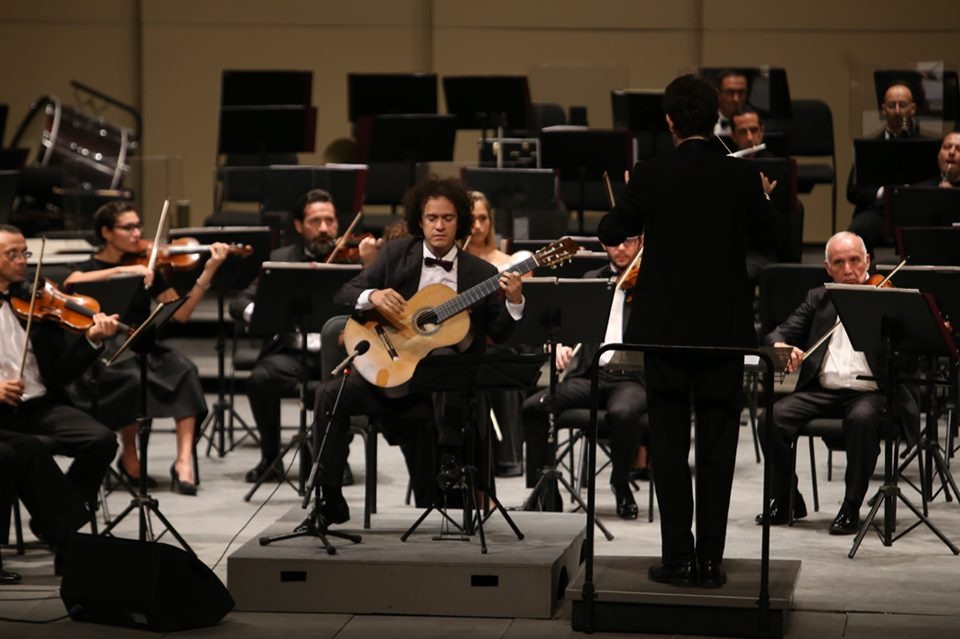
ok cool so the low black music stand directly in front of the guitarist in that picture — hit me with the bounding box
[400,352,545,554]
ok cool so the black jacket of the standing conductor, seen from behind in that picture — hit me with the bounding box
[597,140,773,346]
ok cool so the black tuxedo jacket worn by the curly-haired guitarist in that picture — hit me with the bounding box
[333,237,516,352]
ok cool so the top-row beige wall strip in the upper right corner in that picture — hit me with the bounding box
[703,0,960,33]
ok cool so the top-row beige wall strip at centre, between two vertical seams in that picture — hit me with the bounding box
[433,0,701,31]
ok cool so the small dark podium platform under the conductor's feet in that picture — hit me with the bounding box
[566,556,800,637]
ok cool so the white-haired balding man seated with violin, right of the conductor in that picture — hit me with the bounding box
[757,231,920,535]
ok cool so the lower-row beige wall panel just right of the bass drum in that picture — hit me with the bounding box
[143,25,428,223]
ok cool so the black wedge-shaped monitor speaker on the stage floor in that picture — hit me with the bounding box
[60,534,234,632]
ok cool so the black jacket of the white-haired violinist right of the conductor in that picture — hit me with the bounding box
[764,286,920,435]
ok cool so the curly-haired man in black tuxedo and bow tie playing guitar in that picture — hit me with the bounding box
[314,176,523,525]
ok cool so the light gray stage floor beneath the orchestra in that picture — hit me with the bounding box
[0,388,960,639]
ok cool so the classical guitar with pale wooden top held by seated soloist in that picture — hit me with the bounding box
[343,238,579,388]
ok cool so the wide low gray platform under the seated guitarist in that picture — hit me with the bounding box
[227,508,586,619]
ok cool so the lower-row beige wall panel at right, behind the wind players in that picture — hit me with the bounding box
[703,30,958,242]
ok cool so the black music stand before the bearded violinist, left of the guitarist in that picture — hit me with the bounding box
[243,262,361,501]
